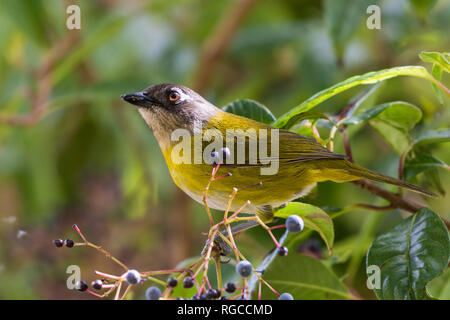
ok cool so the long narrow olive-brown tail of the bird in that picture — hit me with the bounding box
[345,160,437,198]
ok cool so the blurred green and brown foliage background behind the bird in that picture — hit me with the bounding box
[0,0,450,299]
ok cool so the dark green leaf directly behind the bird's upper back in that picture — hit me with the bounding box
[222,99,275,124]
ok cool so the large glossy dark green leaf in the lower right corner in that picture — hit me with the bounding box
[367,208,450,299]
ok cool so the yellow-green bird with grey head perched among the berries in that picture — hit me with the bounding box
[122,84,434,222]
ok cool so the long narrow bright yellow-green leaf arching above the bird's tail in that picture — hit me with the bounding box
[273,66,434,128]
